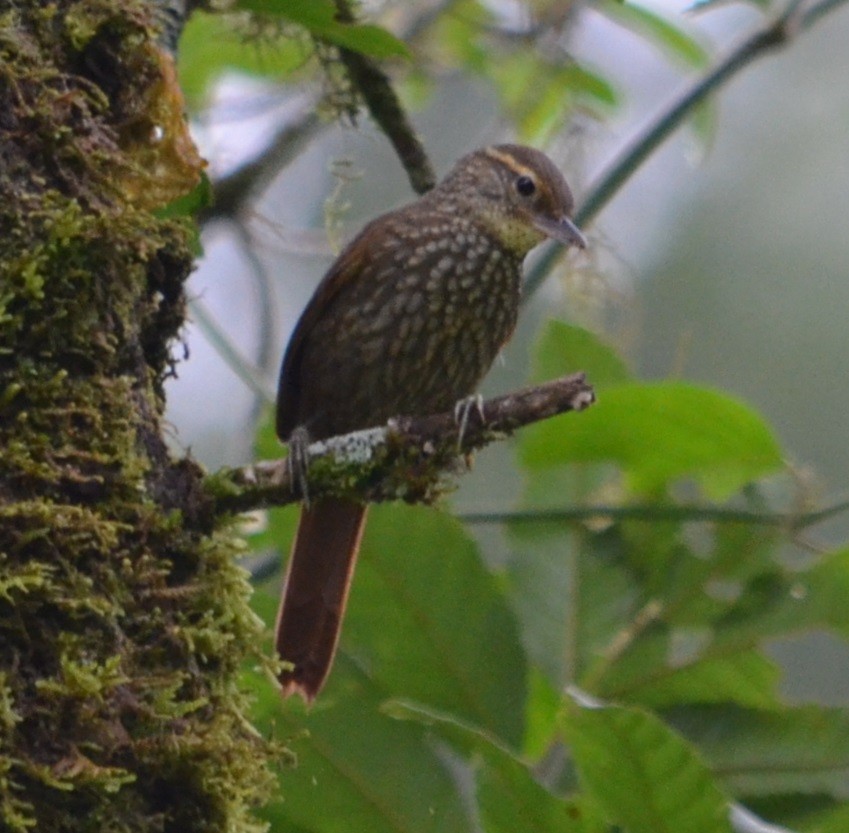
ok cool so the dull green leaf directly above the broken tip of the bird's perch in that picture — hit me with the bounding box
[531,319,631,392]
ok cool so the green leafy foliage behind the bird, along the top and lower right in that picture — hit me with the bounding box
[176,0,849,833]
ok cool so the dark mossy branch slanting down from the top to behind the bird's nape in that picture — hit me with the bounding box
[336,0,436,194]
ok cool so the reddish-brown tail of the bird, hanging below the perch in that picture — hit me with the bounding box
[275,498,366,703]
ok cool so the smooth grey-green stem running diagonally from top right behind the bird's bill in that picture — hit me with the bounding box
[523,0,846,302]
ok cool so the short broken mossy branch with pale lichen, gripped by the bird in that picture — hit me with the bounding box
[207,373,595,514]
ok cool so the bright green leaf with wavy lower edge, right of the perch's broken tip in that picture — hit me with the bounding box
[522,382,781,498]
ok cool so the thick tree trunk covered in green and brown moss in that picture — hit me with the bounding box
[0,0,269,833]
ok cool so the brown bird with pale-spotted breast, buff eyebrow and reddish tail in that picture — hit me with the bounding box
[275,144,586,703]
